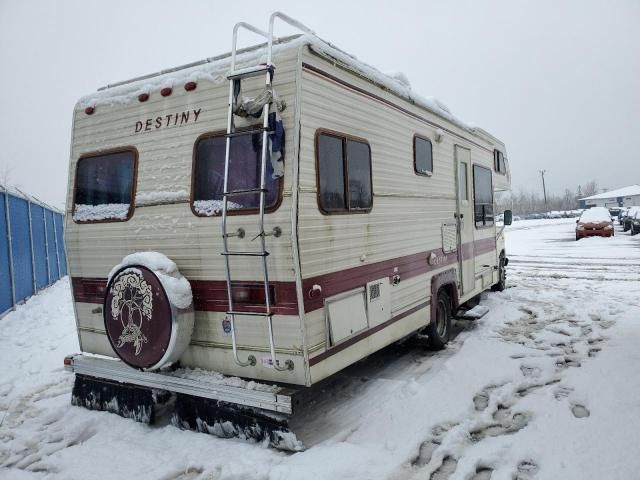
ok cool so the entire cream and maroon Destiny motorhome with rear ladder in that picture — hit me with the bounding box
[65,13,510,446]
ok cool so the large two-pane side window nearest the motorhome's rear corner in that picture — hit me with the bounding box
[316,131,373,213]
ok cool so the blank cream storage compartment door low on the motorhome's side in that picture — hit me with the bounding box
[326,288,367,345]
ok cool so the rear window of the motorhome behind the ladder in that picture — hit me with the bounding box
[191,133,282,217]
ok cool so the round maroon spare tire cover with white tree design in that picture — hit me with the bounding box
[103,265,186,370]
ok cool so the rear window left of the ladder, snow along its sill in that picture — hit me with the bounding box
[73,149,137,223]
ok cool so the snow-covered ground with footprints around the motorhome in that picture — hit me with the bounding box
[0,219,640,480]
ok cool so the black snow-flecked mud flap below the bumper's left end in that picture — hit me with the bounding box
[71,374,155,424]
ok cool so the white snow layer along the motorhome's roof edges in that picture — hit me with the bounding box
[78,33,502,143]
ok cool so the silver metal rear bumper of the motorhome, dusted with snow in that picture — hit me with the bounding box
[64,354,297,415]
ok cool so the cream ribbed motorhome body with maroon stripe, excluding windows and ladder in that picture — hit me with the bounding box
[65,31,509,386]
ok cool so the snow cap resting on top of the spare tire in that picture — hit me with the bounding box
[107,252,193,309]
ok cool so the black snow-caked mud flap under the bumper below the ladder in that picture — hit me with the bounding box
[171,394,304,451]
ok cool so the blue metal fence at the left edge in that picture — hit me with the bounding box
[0,185,67,316]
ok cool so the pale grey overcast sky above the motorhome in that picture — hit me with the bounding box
[0,0,640,207]
